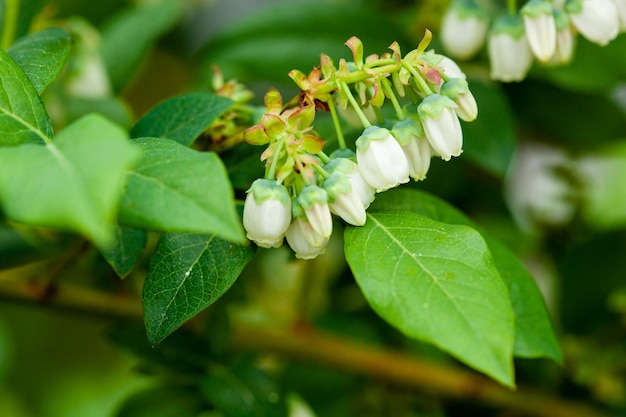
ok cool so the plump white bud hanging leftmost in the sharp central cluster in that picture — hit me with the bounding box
[243,179,291,248]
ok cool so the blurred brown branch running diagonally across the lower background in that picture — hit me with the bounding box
[0,277,609,417]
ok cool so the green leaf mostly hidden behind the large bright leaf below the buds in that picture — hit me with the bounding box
[371,188,562,363]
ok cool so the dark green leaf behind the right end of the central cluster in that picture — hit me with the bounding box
[463,80,516,178]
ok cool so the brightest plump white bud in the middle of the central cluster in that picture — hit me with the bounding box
[356,126,409,192]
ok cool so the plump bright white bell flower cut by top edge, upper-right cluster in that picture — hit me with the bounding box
[565,0,620,46]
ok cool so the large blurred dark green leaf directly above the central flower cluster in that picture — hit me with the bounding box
[197,2,414,86]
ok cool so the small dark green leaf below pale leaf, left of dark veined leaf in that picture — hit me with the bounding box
[100,225,148,278]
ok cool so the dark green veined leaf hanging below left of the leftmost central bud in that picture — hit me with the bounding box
[143,233,253,344]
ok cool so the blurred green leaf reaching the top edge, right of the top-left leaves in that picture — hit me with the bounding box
[102,1,184,91]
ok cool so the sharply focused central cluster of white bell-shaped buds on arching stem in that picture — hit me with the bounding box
[243,31,478,259]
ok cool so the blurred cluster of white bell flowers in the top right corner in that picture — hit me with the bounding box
[441,0,626,82]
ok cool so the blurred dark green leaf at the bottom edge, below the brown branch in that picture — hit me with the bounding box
[200,364,287,417]
